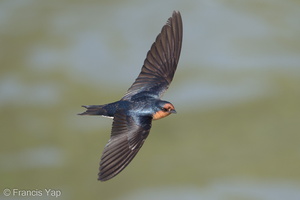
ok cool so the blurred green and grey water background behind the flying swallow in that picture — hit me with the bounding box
[0,0,300,200]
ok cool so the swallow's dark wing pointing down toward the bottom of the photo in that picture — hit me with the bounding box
[98,110,152,181]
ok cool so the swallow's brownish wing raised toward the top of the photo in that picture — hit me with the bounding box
[122,11,182,100]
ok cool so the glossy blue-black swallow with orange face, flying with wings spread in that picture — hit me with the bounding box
[79,11,183,181]
